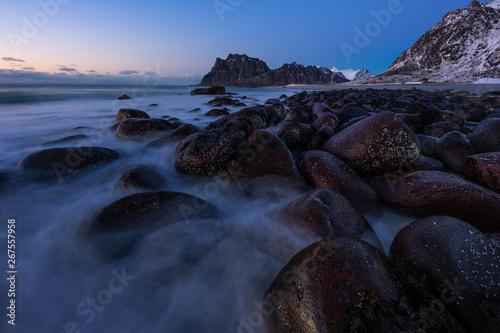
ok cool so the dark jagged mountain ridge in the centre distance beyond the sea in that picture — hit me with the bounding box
[199,54,347,87]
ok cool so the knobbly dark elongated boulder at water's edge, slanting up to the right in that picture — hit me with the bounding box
[175,107,267,176]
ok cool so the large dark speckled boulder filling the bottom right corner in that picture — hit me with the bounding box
[390,216,500,332]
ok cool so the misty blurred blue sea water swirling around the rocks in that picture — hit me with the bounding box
[0,85,411,333]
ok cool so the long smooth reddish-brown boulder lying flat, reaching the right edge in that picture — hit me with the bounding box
[370,171,500,231]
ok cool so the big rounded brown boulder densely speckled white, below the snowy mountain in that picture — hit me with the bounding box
[322,112,420,177]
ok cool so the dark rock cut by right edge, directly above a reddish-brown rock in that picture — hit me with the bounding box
[467,118,500,153]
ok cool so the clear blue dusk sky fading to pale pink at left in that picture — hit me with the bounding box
[0,0,487,84]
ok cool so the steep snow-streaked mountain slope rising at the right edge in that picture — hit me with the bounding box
[377,0,500,82]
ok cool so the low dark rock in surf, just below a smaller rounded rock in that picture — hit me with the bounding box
[116,119,176,141]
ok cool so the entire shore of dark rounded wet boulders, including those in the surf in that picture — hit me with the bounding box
[11,84,500,333]
